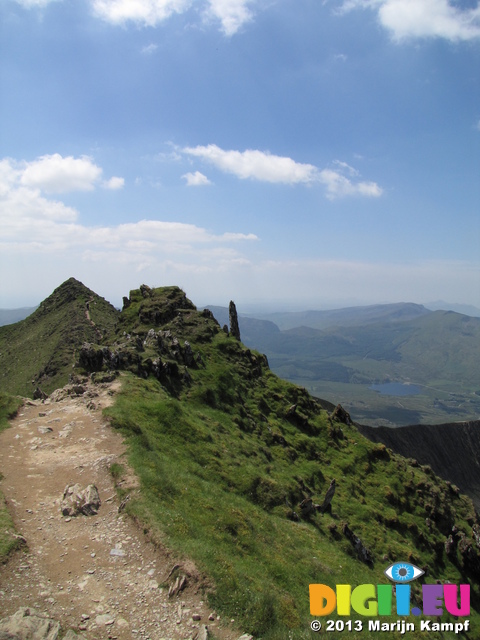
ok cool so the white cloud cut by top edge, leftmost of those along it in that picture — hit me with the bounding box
[92,0,192,27]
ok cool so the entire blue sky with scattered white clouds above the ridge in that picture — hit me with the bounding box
[0,0,480,310]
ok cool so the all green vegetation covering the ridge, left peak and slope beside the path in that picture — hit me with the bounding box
[0,280,480,640]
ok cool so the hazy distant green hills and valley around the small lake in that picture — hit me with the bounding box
[210,305,480,426]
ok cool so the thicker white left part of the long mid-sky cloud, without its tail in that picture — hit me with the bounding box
[183,144,317,184]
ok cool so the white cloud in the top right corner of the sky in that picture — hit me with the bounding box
[341,0,480,42]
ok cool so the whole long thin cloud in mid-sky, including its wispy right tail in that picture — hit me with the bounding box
[182,144,382,200]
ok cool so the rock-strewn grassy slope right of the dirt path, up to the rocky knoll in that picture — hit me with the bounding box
[98,288,480,639]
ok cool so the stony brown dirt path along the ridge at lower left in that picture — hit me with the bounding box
[0,382,240,640]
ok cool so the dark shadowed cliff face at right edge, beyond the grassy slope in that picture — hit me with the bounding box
[358,420,480,511]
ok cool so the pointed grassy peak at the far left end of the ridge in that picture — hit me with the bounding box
[0,278,118,397]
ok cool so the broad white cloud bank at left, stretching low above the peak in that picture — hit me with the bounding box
[0,158,258,262]
